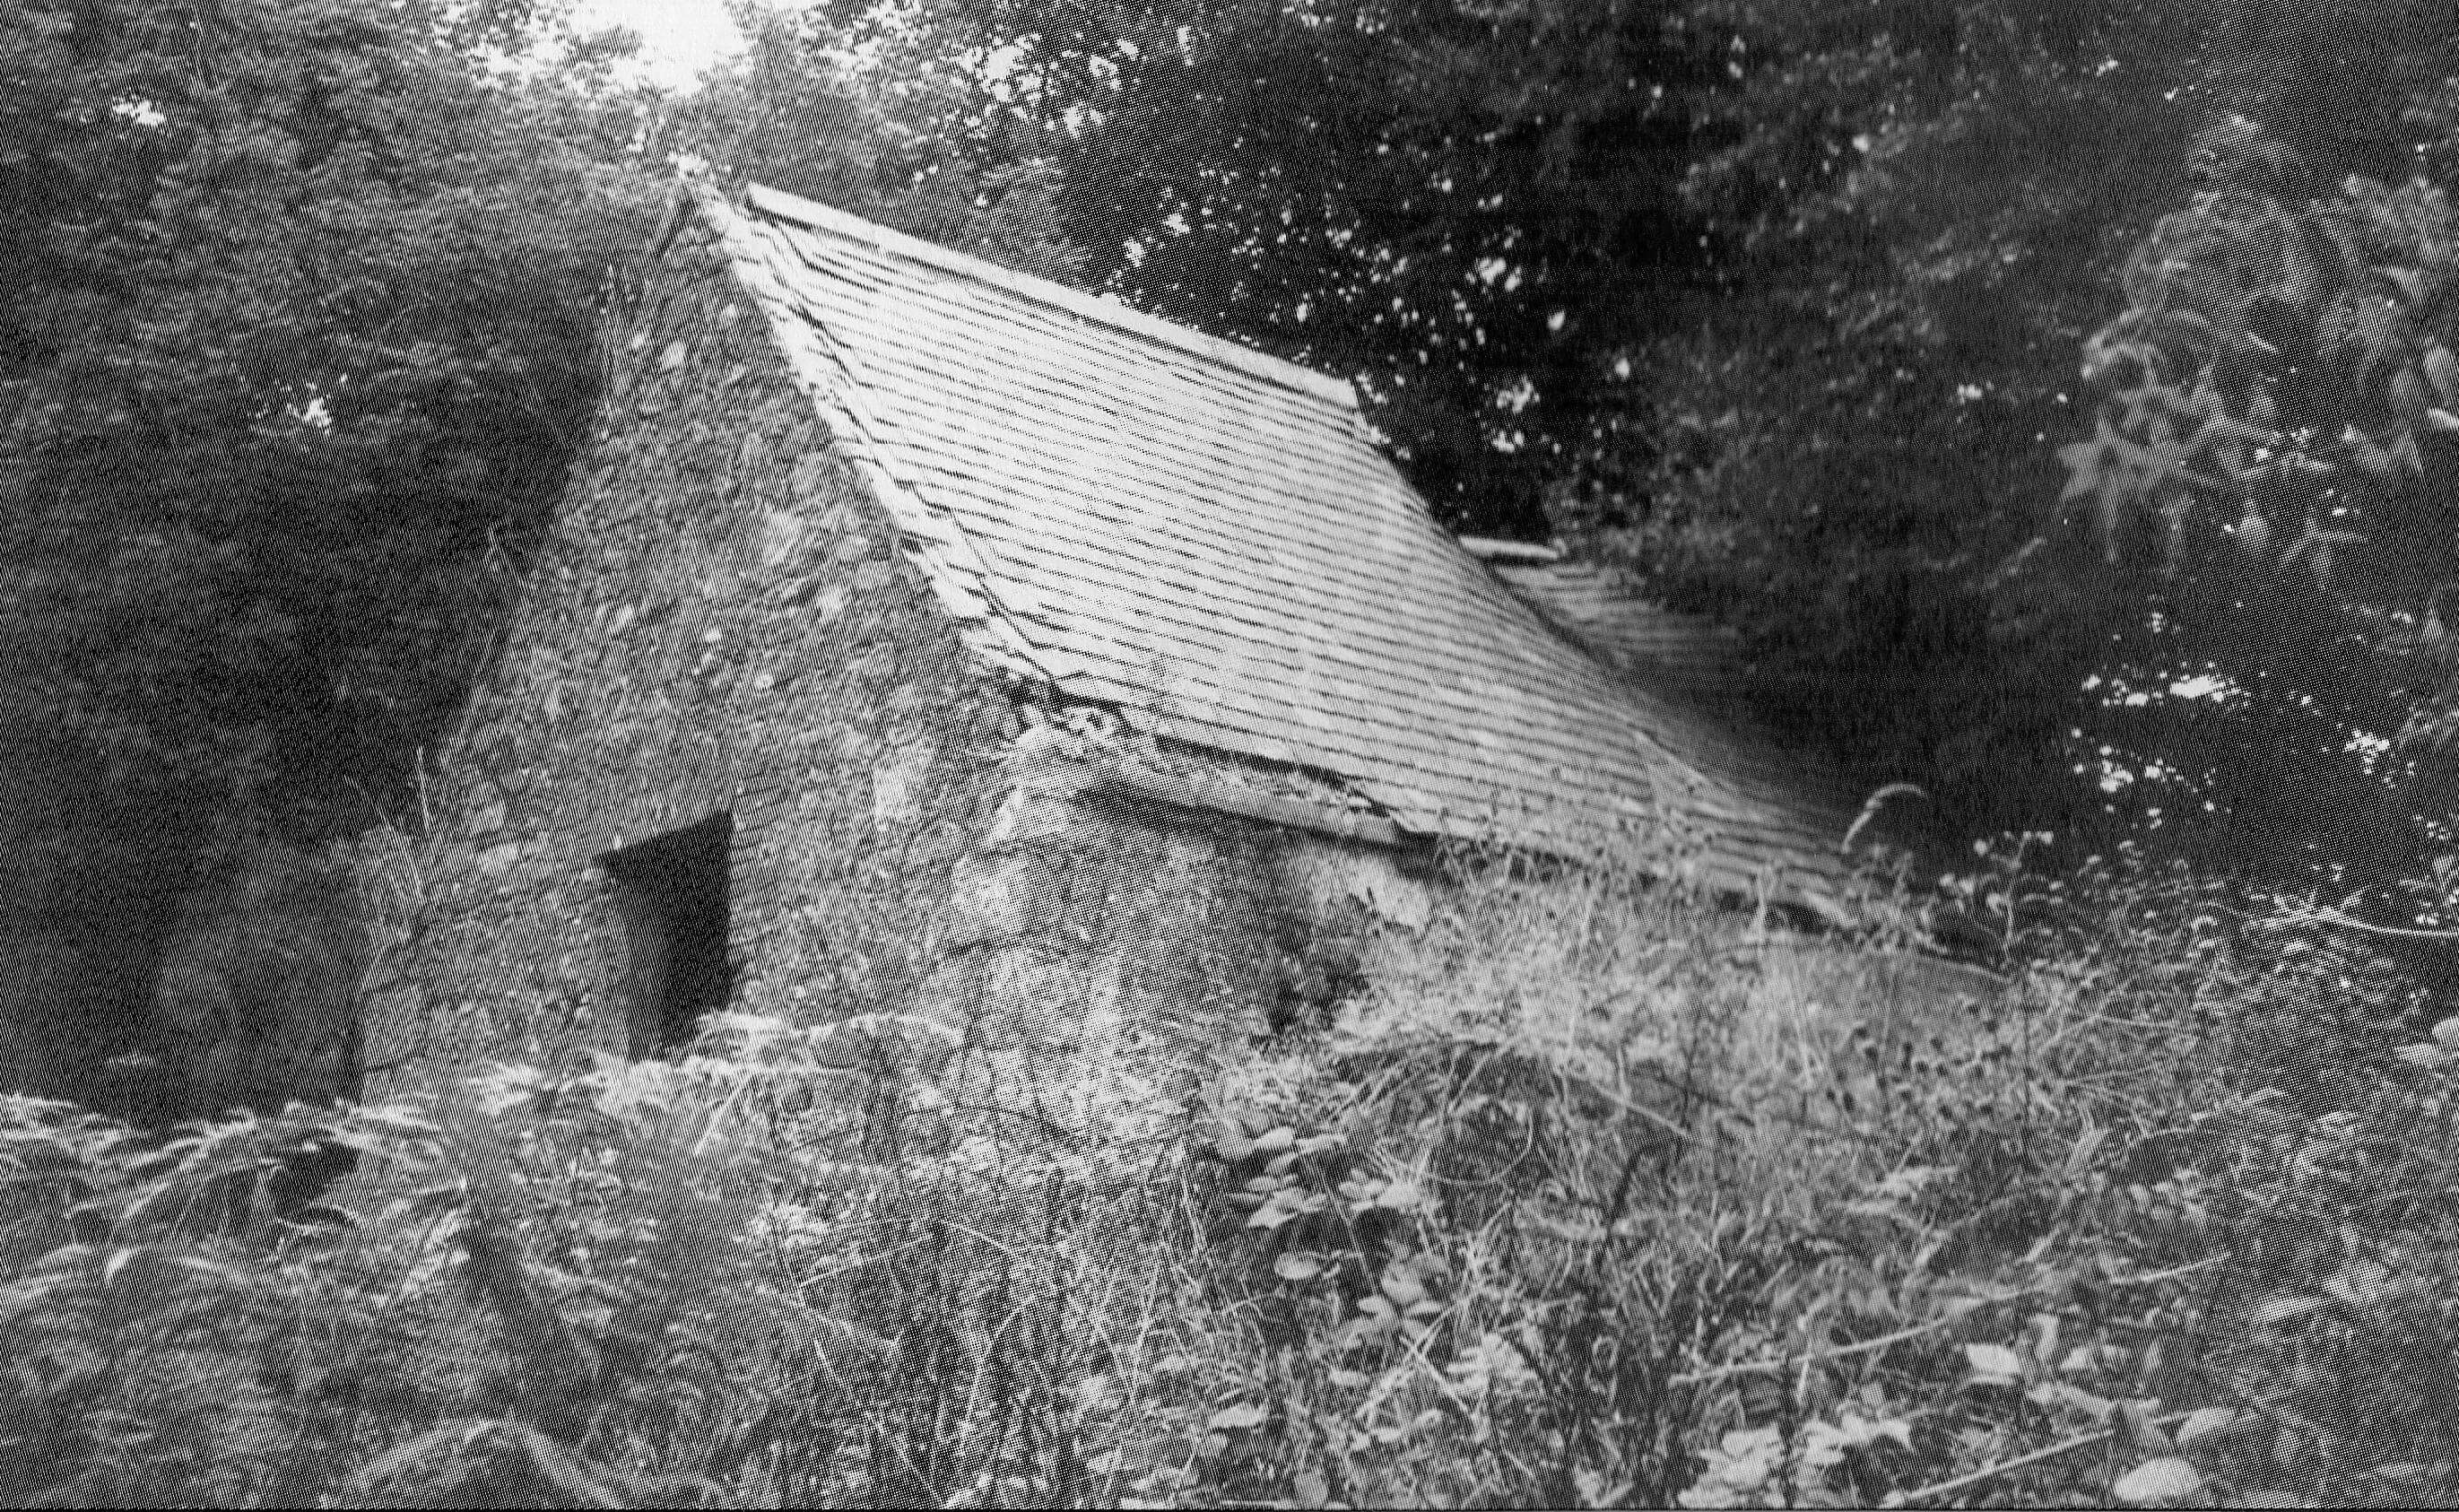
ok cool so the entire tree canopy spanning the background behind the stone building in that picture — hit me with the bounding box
[14,0,2459,899]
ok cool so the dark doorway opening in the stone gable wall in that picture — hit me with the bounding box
[597,813,735,1060]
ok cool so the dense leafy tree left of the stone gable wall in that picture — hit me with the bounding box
[0,0,654,870]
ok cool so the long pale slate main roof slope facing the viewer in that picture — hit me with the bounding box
[693,185,1846,898]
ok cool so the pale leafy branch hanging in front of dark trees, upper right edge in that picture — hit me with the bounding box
[2058,118,2459,593]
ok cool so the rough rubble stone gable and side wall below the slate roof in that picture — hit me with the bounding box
[361,210,1404,1111]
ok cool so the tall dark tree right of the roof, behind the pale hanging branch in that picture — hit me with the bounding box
[1623,0,2446,868]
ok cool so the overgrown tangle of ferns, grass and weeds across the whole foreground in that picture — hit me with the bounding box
[0,848,2459,1508]
